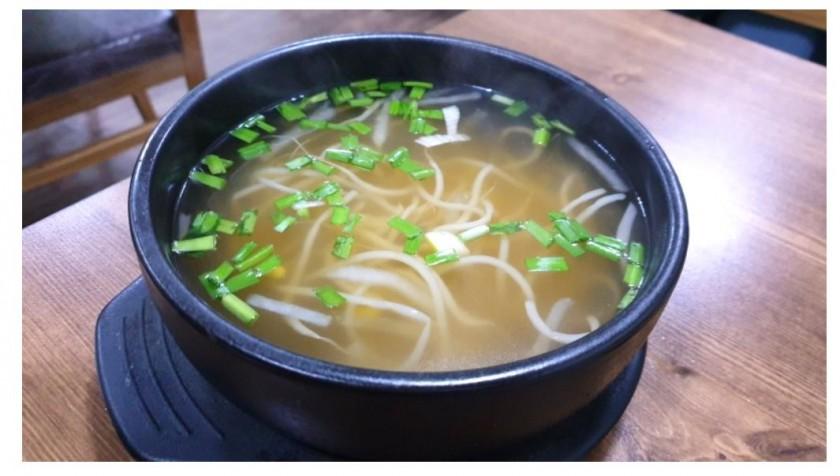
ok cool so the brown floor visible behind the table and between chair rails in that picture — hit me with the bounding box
[22,10,460,226]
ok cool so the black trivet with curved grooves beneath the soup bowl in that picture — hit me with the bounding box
[96,279,645,461]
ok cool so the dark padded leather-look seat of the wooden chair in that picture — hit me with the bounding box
[23,10,181,104]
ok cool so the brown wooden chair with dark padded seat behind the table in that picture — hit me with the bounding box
[23,10,206,192]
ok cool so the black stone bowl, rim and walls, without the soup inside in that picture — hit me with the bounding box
[129,34,688,458]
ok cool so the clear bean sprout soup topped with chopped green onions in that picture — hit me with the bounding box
[172,80,646,371]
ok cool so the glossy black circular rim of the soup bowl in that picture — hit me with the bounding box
[128,33,688,392]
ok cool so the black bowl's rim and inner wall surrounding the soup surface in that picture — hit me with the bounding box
[129,34,688,384]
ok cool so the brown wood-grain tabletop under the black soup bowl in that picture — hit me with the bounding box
[23,11,826,460]
